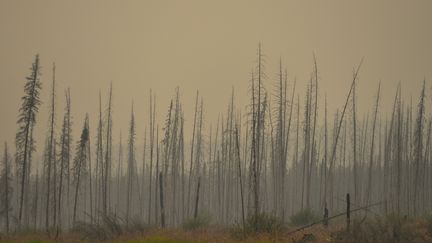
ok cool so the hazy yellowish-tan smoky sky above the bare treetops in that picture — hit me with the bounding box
[0,0,432,148]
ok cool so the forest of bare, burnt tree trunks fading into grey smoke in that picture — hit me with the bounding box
[0,44,432,242]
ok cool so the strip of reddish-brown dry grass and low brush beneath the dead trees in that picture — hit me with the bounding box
[0,219,432,243]
